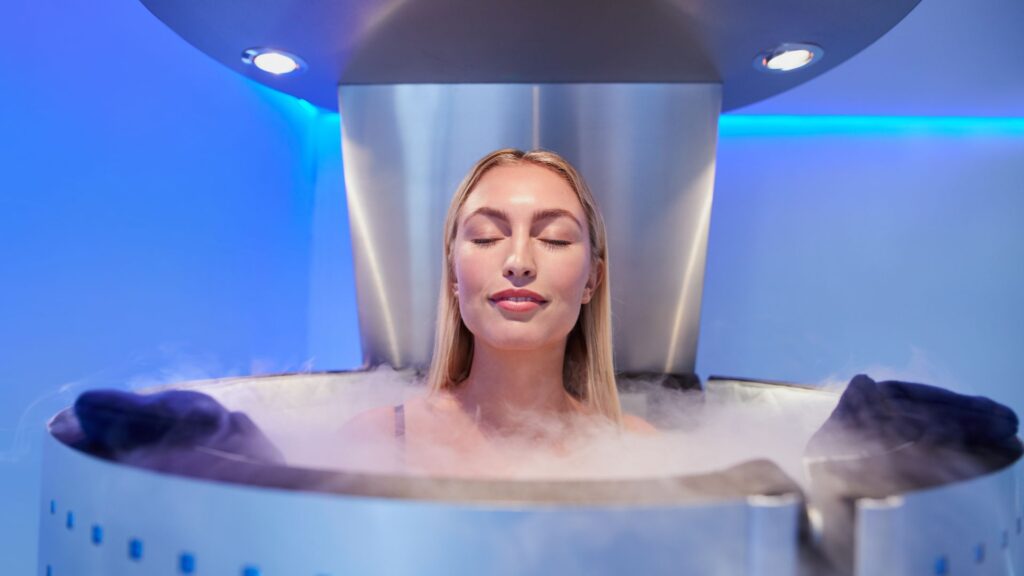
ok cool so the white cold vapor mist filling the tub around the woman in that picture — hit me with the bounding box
[188,368,838,484]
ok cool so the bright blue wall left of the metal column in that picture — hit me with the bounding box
[0,0,359,575]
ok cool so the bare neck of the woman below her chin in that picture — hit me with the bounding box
[453,339,577,430]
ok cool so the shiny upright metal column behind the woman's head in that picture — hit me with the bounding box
[339,84,721,373]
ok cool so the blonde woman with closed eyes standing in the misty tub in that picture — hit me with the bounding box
[343,149,654,475]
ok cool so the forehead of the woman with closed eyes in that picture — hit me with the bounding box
[460,164,585,222]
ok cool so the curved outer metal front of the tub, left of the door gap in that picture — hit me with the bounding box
[37,430,799,576]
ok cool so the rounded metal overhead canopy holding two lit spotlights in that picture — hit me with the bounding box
[140,0,920,111]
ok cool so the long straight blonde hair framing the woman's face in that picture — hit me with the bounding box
[427,149,622,423]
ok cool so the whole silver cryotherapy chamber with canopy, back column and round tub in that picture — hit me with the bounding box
[39,0,1024,576]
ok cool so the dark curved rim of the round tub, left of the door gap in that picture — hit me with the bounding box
[47,368,804,507]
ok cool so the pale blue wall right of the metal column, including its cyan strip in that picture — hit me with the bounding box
[697,116,1024,403]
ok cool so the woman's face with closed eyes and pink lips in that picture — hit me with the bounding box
[452,164,599,349]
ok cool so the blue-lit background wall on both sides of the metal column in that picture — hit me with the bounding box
[0,0,1024,574]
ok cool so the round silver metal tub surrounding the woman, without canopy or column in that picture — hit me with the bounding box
[37,372,1024,576]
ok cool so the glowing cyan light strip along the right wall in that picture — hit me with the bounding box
[718,114,1024,137]
